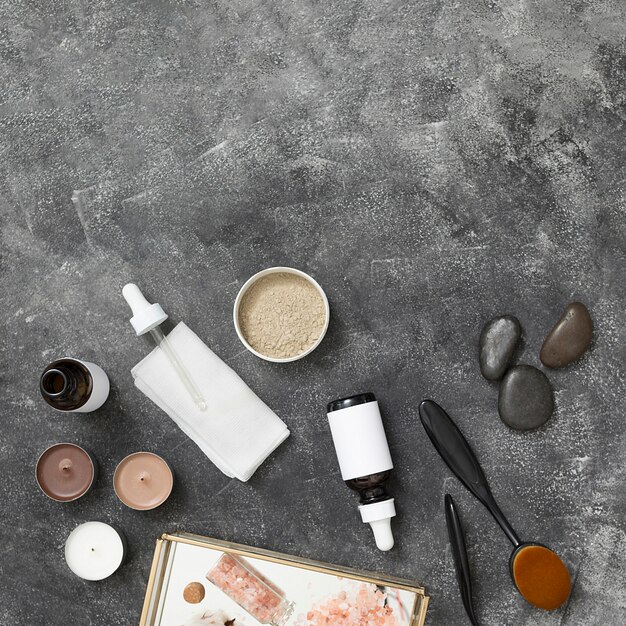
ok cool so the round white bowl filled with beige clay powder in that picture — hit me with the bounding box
[239,272,326,359]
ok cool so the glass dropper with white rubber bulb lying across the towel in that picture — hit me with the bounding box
[122,283,207,411]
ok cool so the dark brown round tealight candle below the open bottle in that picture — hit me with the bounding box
[35,443,96,502]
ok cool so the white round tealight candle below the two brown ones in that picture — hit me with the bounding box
[65,522,126,580]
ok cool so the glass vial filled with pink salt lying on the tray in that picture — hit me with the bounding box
[206,554,289,624]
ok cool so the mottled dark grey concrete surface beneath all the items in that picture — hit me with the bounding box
[0,0,626,626]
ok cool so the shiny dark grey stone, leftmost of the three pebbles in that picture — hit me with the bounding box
[478,315,522,380]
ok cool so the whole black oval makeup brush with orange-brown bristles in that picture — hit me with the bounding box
[419,400,572,611]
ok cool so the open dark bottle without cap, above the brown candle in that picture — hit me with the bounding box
[39,357,109,413]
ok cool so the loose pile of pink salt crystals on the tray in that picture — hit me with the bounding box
[297,584,398,626]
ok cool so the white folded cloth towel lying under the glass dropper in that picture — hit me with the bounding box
[131,322,289,481]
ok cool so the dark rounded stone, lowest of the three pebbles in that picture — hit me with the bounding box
[498,365,554,430]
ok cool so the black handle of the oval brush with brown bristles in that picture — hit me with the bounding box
[420,400,521,548]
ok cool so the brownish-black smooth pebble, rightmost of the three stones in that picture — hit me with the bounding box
[539,302,593,369]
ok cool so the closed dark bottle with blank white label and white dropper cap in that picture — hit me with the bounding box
[328,393,396,550]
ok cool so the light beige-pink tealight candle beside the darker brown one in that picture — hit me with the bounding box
[113,452,174,511]
